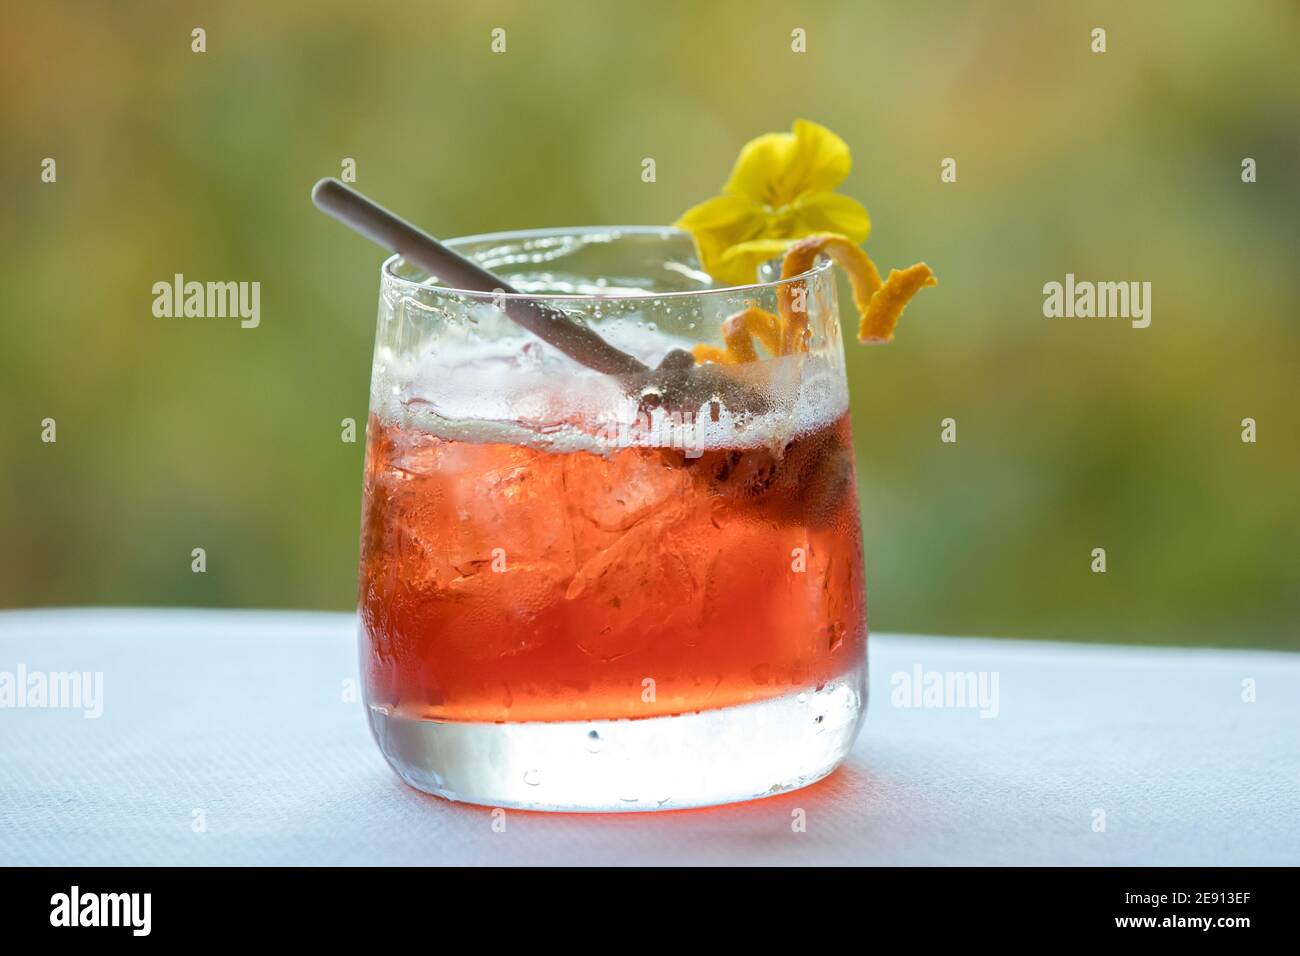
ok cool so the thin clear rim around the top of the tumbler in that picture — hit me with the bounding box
[380,225,835,302]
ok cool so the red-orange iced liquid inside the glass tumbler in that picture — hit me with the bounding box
[360,415,866,722]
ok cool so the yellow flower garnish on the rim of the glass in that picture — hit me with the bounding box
[673,120,871,285]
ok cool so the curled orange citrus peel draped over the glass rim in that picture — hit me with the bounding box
[692,233,939,365]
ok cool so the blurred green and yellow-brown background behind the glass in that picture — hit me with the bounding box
[0,0,1300,648]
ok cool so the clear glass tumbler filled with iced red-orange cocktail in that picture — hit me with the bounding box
[359,228,867,810]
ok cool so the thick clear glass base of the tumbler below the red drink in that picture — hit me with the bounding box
[369,667,866,813]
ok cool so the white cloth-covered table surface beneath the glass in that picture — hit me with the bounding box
[0,610,1300,865]
